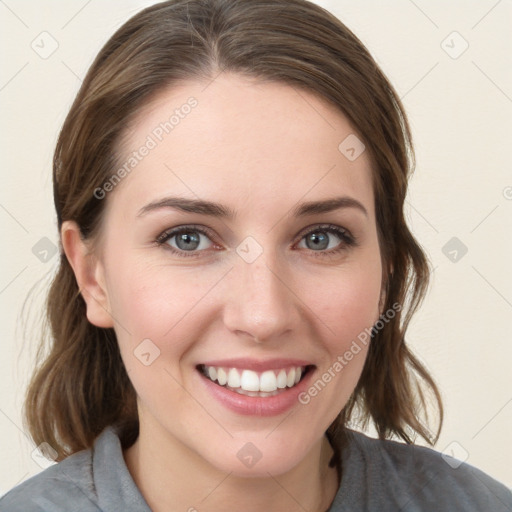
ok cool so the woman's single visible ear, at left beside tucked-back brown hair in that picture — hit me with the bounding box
[61,221,114,328]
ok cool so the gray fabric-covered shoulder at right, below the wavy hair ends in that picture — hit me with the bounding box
[332,431,512,512]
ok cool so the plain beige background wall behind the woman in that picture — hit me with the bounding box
[0,0,512,495]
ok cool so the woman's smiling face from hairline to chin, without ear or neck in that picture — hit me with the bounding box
[88,74,382,476]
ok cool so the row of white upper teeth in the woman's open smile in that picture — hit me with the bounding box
[203,366,305,396]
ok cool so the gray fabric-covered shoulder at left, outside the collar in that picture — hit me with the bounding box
[0,450,99,512]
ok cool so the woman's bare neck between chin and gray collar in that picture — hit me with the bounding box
[124,425,339,512]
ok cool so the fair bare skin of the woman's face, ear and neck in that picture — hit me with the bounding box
[61,74,382,512]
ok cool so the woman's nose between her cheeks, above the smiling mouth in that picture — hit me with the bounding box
[223,255,301,343]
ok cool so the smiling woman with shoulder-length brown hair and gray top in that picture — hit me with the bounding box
[0,0,512,512]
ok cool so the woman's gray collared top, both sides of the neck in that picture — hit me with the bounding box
[0,427,512,512]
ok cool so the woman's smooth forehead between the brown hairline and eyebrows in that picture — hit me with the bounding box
[109,74,373,220]
